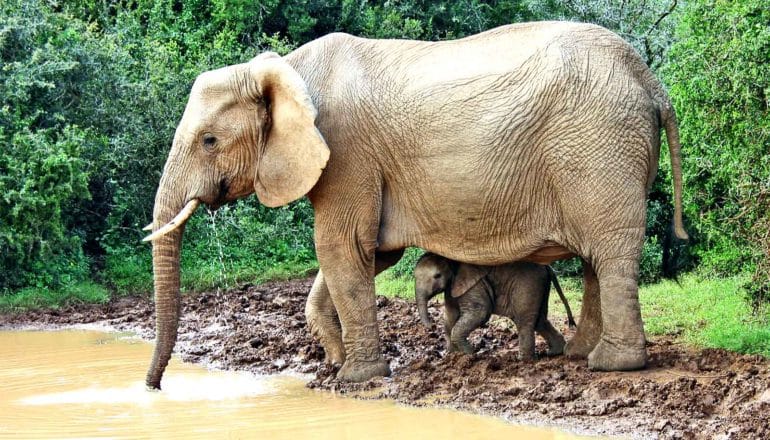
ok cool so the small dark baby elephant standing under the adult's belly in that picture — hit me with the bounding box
[414,253,575,360]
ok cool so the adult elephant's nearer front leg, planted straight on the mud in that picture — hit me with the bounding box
[316,243,390,382]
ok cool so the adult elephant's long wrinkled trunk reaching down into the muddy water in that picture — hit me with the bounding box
[146,165,197,389]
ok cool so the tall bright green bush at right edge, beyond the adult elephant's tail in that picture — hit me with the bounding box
[663,0,770,305]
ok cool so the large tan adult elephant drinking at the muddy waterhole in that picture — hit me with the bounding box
[142,22,686,388]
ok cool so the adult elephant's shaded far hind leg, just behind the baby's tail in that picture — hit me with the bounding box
[564,260,602,359]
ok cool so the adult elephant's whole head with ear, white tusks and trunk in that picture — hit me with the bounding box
[145,53,329,389]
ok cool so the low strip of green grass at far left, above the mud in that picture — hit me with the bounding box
[0,282,110,312]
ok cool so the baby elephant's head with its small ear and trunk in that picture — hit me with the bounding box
[414,253,489,326]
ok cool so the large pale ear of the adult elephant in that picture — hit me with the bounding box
[249,52,329,207]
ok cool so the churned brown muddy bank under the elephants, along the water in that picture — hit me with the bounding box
[0,280,770,439]
